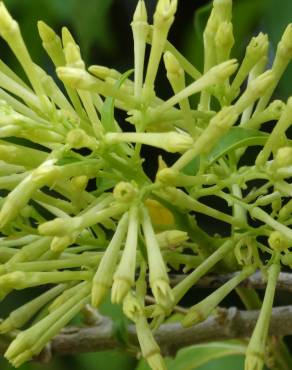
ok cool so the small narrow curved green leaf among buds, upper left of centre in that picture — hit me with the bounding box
[101,69,134,132]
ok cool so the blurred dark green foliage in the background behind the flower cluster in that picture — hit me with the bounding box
[0,0,292,370]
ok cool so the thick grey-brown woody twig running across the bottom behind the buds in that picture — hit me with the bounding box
[4,306,292,361]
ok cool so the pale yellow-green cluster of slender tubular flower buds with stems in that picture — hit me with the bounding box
[0,0,292,370]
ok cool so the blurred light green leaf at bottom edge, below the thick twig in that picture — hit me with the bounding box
[136,341,246,370]
